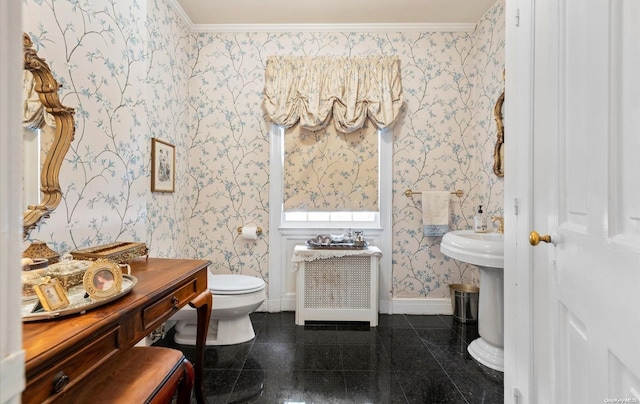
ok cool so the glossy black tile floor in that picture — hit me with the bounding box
[156,312,504,404]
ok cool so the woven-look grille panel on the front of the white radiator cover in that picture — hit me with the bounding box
[304,256,371,309]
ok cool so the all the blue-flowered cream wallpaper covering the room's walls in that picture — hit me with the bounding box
[23,0,504,304]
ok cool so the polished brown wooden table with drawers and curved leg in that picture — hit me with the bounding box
[22,257,211,403]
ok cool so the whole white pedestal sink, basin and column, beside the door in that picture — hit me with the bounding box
[440,230,504,372]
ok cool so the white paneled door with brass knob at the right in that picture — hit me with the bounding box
[530,0,640,403]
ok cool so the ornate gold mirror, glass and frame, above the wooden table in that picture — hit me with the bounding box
[22,33,75,238]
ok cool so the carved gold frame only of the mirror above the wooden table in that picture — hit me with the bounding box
[22,33,75,239]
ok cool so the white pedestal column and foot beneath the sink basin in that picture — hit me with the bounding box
[467,265,504,372]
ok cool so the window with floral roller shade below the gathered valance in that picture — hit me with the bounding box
[272,125,392,228]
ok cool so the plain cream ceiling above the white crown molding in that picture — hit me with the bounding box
[174,0,499,25]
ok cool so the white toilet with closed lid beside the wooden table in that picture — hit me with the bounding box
[170,273,266,345]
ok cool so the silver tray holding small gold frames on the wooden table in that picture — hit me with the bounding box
[22,275,138,322]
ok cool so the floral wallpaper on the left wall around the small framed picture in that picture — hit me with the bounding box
[23,0,190,256]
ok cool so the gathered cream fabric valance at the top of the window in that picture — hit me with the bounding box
[264,56,402,133]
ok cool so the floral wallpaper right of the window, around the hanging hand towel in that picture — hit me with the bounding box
[393,2,504,297]
